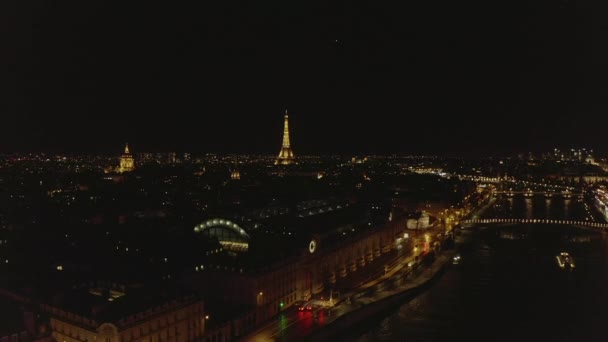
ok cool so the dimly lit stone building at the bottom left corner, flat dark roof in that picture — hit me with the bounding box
[40,284,205,342]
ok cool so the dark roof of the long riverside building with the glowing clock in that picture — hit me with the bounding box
[197,201,389,272]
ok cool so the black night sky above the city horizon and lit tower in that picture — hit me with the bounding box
[0,0,608,155]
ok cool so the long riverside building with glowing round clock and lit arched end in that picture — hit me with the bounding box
[185,201,406,338]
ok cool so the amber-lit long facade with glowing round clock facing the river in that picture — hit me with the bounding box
[188,214,406,340]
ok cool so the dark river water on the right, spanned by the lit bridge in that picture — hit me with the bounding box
[347,197,608,342]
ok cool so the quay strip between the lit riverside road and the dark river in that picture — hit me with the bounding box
[304,250,456,341]
